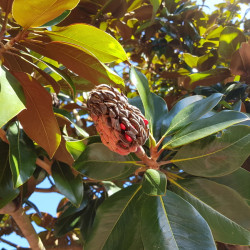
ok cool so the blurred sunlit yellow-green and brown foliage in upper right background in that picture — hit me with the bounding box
[65,0,250,107]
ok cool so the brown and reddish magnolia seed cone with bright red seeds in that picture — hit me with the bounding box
[87,84,149,155]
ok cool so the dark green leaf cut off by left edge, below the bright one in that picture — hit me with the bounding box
[0,140,19,208]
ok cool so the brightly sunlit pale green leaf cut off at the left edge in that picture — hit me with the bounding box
[0,67,25,128]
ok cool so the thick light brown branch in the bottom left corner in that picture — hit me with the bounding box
[0,202,45,250]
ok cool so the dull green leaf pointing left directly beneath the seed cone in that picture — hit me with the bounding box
[74,143,140,180]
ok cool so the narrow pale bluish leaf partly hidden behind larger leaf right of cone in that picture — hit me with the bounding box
[161,95,203,135]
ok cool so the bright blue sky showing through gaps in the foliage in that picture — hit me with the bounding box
[0,0,250,250]
